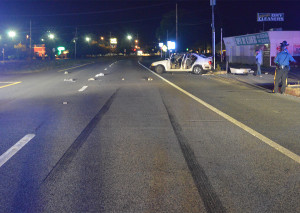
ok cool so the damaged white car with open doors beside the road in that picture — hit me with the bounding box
[150,53,212,75]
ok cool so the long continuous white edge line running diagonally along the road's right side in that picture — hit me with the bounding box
[138,62,300,164]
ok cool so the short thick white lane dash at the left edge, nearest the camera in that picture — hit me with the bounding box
[0,134,35,167]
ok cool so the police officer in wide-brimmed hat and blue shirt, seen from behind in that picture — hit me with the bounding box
[274,41,296,94]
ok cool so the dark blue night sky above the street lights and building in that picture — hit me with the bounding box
[0,0,300,50]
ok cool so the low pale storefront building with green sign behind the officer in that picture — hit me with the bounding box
[223,31,300,66]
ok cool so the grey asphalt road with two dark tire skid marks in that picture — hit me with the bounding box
[0,58,300,212]
